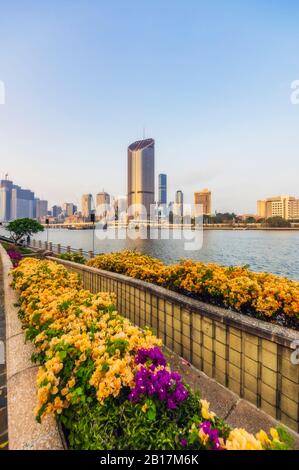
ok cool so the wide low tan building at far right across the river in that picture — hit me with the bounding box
[257,195,299,220]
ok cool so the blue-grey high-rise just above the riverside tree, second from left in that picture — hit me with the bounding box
[10,186,35,220]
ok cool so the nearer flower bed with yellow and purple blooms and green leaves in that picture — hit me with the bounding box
[13,258,290,450]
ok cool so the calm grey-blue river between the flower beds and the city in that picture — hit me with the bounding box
[2,229,299,280]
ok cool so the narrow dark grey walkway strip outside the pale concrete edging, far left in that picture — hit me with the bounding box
[0,260,8,450]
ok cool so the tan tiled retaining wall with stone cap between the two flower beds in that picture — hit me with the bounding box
[48,257,299,432]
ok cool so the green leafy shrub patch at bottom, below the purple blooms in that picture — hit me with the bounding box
[60,394,207,450]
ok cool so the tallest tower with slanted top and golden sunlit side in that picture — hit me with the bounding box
[128,139,155,219]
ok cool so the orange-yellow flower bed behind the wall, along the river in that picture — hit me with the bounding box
[87,251,299,329]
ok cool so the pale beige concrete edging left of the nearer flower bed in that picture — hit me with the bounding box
[0,245,64,450]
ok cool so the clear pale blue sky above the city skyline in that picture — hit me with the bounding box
[0,0,299,213]
